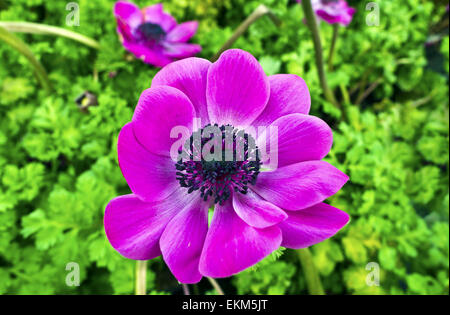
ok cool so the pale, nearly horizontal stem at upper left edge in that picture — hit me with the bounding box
[0,21,100,49]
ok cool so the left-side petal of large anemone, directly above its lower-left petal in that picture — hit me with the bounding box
[117,123,179,202]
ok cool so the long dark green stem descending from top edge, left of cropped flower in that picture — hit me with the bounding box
[302,0,340,109]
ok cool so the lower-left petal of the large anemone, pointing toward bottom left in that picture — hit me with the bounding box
[104,195,183,260]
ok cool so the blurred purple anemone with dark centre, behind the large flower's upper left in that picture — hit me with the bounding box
[114,1,202,67]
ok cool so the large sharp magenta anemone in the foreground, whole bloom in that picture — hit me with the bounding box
[104,49,349,283]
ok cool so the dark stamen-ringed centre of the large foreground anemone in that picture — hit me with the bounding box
[175,124,261,205]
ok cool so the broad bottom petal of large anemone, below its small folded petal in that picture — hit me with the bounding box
[200,201,281,278]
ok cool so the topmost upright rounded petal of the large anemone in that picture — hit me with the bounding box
[206,49,270,127]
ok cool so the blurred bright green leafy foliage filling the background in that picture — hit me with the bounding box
[0,0,449,294]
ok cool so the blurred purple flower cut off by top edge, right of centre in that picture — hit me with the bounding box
[297,0,356,26]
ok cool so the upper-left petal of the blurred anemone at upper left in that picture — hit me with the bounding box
[113,1,143,40]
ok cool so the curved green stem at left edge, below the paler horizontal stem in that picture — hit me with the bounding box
[0,25,52,93]
